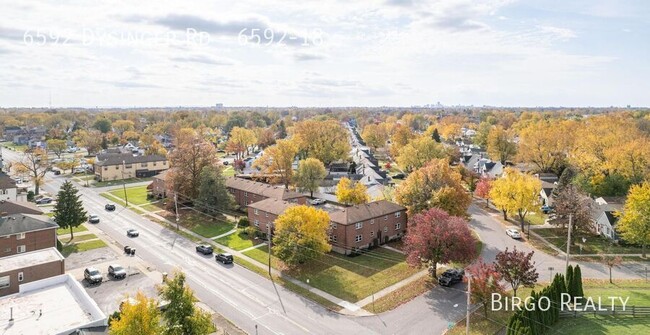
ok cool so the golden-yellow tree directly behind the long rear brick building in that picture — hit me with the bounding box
[254,140,298,189]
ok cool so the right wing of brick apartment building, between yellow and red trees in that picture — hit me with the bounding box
[330,200,407,255]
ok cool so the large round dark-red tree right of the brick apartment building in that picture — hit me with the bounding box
[404,208,478,278]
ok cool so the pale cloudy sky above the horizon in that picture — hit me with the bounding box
[0,0,650,108]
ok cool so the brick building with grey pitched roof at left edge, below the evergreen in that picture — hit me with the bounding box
[0,213,59,257]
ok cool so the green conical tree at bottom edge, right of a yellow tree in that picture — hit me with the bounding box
[160,272,215,335]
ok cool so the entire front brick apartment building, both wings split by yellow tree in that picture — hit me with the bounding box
[248,198,407,255]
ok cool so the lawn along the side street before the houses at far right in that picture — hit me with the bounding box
[534,228,641,255]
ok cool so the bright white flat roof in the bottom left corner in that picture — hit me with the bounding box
[0,274,107,335]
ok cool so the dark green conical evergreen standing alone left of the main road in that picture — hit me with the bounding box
[53,181,88,239]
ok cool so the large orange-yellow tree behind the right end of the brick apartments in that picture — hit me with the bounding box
[395,159,472,216]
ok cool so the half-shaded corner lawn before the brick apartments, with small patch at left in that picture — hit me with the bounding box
[245,246,418,302]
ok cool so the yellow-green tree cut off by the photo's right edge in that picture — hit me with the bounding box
[617,182,650,257]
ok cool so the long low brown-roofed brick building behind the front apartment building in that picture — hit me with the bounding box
[226,177,307,209]
